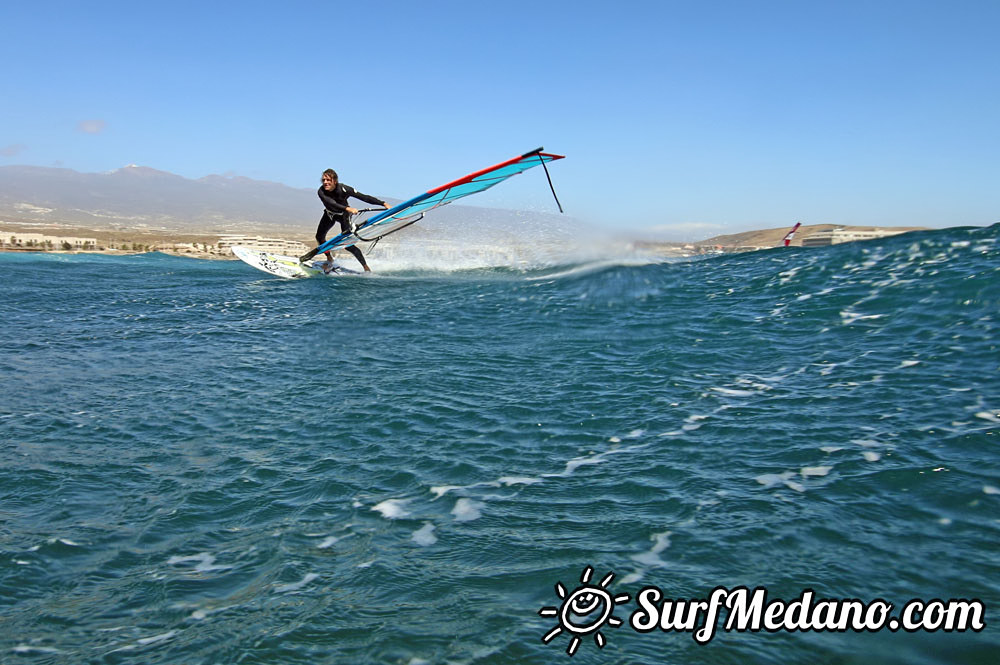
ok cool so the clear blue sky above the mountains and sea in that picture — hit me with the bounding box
[0,0,1000,239]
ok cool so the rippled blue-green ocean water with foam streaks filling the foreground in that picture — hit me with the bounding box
[0,226,1000,665]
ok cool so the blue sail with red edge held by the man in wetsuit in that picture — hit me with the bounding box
[302,148,563,261]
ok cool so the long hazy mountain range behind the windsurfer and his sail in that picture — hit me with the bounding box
[0,164,580,241]
